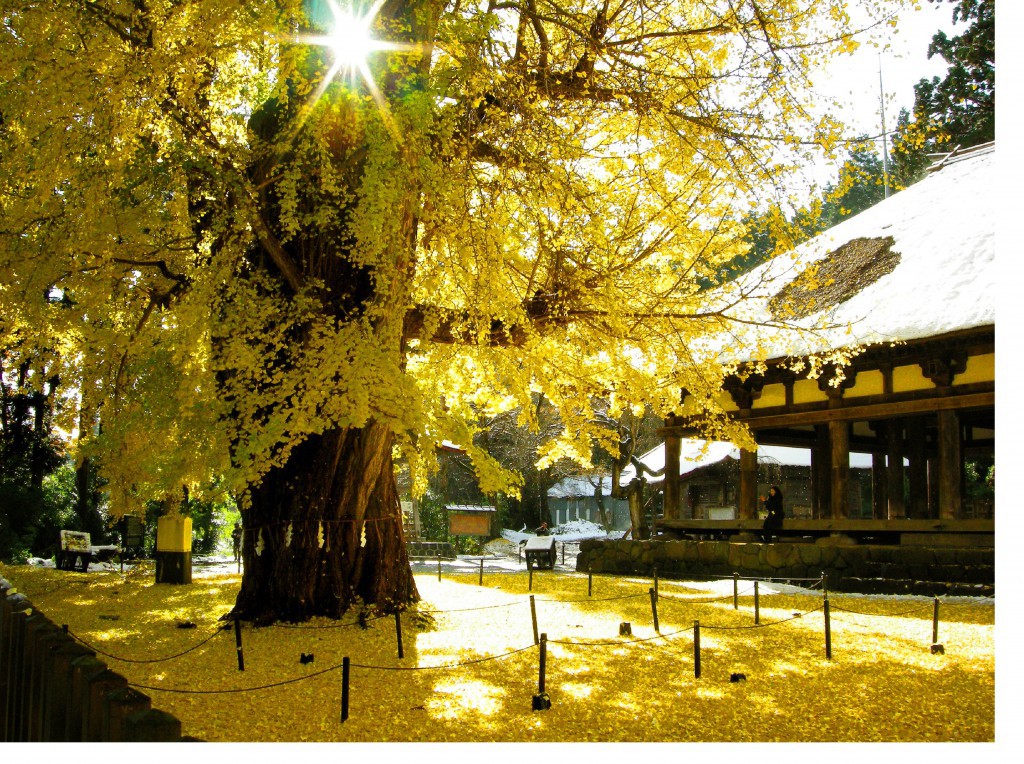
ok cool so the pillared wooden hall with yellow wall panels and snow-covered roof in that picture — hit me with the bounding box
[656,143,996,546]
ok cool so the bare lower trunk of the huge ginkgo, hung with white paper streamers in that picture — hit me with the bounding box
[232,423,418,623]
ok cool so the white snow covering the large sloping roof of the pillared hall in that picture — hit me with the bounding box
[719,143,996,359]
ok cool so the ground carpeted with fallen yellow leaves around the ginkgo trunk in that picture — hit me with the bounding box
[0,565,995,742]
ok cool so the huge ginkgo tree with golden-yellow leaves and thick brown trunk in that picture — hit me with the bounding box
[0,0,899,623]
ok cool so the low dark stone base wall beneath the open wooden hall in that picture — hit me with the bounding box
[577,539,995,596]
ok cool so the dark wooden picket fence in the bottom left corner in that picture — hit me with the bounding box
[0,578,188,742]
